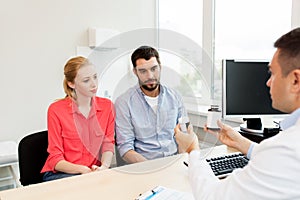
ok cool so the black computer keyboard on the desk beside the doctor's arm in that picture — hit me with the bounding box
[206,153,249,179]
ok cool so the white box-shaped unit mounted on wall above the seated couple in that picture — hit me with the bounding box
[88,27,120,49]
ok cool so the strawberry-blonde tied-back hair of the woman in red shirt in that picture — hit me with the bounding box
[63,56,90,99]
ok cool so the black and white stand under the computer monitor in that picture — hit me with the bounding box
[240,118,264,135]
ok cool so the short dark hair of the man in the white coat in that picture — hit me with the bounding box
[274,28,300,76]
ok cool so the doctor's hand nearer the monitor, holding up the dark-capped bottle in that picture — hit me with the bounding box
[204,120,251,154]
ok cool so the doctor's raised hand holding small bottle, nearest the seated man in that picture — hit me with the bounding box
[174,124,200,153]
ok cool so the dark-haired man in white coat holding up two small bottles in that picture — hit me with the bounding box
[175,28,300,200]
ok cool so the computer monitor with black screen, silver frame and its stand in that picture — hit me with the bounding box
[222,60,285,133]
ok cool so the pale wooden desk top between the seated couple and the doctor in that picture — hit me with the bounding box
[0,145,235,200]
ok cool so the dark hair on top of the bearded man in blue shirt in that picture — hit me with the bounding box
[131,46,160,68]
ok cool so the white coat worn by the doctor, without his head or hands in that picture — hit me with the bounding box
[189,118,300,200]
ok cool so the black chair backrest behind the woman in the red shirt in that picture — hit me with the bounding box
[18,131,48,186]
